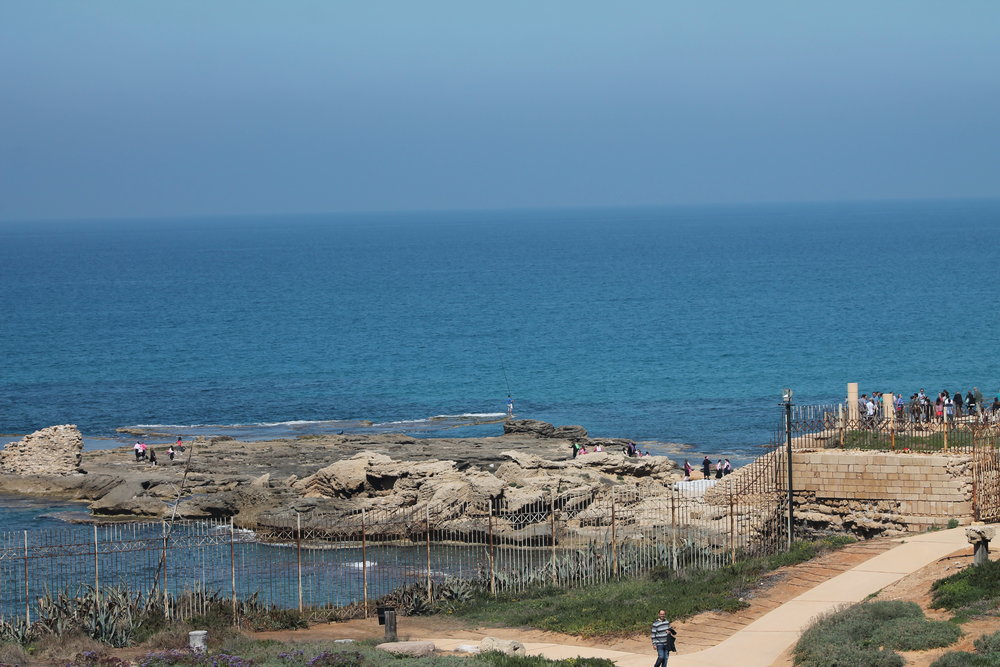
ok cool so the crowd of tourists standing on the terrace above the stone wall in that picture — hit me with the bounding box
[858,387,1000,428]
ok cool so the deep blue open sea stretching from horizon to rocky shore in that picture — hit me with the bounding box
[0,201,1000,528]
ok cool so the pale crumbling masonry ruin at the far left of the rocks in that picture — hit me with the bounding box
[0,424,83,475]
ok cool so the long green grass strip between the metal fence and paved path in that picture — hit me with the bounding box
[442,536,855,637]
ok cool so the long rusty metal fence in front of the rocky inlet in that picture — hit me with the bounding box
[0,451,786,621]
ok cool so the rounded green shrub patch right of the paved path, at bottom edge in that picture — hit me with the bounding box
[795,600,962,667]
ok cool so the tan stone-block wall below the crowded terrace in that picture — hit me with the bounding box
[792,450,972,536]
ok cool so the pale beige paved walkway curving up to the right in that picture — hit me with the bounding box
[425,528,970,667]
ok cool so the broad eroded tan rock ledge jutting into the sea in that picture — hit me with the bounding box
[0,420,680,527]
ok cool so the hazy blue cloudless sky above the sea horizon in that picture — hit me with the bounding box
[0,0,1000,220]
